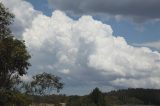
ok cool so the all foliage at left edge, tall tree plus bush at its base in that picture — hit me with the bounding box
[0,3,31,106]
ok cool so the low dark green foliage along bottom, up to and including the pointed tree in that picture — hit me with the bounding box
[33,88,112,106]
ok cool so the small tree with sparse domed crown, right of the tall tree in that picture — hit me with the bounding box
[25,72,63,95]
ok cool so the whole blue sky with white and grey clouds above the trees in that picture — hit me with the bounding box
[0,0,160,95]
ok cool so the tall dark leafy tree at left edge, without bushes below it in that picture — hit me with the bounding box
[0,3,31,90]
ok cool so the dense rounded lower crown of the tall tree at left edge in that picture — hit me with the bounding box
[0,37,30,89]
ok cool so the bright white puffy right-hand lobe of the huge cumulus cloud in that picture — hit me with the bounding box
[89,37,160,77]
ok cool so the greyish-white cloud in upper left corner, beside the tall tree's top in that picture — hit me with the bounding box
[0,0,42,37]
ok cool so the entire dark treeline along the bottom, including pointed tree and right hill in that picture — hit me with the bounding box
[33,88,160,106]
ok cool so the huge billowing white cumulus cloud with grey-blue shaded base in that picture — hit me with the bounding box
[1,0,160,94]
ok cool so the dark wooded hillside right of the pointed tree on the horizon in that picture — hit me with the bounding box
[105,88,160,105]
